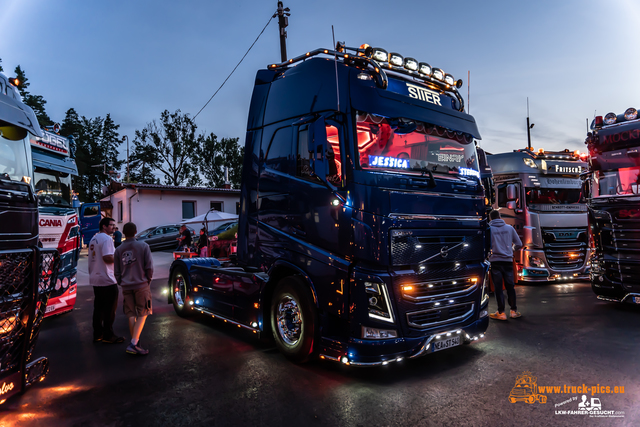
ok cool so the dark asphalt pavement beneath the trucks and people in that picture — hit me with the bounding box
[0,252,640,427]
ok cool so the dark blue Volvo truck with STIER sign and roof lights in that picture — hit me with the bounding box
[167,43,488,366]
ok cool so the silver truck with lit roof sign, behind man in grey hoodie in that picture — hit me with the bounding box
[488,149,589,282]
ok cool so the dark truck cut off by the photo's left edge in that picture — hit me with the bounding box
[0,73,58,404]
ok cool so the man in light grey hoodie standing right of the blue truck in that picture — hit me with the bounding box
[489,210,522,320]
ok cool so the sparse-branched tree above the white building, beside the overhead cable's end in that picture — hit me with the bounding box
[134,110,202,185]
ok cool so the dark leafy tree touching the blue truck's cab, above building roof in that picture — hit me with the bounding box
[198,133,244,188]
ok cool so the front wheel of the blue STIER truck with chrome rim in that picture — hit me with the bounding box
[270,276,318,363]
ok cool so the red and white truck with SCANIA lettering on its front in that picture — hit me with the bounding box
[30,128,80,316]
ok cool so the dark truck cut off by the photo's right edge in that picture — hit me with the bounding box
[585,108,640,304]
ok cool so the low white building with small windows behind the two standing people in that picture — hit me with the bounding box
[100,184,240,231]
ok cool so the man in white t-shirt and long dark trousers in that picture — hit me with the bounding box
[89,218,124,344]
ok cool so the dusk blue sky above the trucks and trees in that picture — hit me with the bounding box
[0,0,640,166]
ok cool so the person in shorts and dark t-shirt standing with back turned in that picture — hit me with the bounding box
[114,222,153,355]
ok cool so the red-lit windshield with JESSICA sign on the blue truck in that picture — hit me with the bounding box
[356,112,480,177]
